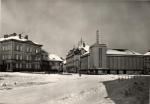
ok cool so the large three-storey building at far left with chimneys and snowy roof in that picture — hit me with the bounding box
[0,33,42,71]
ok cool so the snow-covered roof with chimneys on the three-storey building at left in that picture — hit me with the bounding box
[0,35,40,45]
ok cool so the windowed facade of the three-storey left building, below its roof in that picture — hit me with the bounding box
[1,40,41,71]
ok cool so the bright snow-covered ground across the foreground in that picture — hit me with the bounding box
[0,73,149,104]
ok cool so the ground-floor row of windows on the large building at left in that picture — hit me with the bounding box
[15,63,40,69]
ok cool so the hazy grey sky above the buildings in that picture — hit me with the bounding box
[0,0,150,58]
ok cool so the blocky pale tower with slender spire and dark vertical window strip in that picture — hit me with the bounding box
[90,30,107,70]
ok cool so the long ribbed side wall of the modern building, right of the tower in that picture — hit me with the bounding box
[107,55,143,70]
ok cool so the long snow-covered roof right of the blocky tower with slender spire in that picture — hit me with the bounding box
[107,49,142,55]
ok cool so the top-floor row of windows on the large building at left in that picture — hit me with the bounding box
[2,45,40,53]
